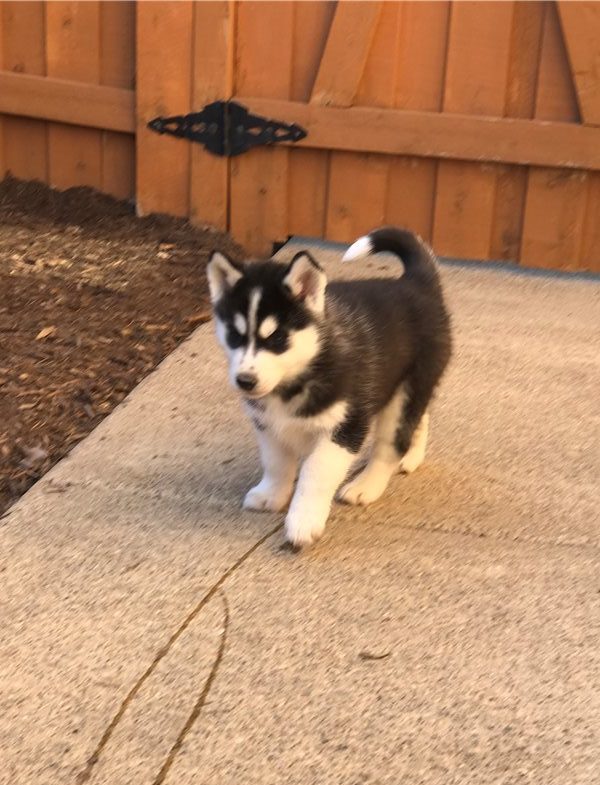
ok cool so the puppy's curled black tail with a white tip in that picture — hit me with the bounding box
[342,226,439,286]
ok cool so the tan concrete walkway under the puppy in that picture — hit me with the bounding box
[0,242,600,785]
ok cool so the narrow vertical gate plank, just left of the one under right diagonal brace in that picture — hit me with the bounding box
[490,0,546,261]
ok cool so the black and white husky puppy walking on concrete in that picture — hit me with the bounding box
[208,228,451,546]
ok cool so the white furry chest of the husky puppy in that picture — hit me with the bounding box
[245,398,348,453]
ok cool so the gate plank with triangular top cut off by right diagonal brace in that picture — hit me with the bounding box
[521,3,588,269]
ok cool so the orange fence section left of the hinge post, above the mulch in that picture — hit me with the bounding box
[0,2,135,198]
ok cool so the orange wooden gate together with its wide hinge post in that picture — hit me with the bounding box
[138,2,600,269]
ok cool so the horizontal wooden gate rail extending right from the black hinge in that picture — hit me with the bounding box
[239,96,600,170]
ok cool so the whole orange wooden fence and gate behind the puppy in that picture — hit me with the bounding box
[0,0,600,271]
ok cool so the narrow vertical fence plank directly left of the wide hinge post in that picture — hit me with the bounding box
[100,0,135,199]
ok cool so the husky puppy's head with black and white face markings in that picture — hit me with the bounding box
[207,251,327,398]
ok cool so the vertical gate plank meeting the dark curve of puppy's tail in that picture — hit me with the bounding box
[385,1,450,242]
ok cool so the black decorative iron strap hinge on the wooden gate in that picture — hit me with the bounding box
[148,101,307,157]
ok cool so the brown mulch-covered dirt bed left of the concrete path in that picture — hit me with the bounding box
[0,178,240,514]
